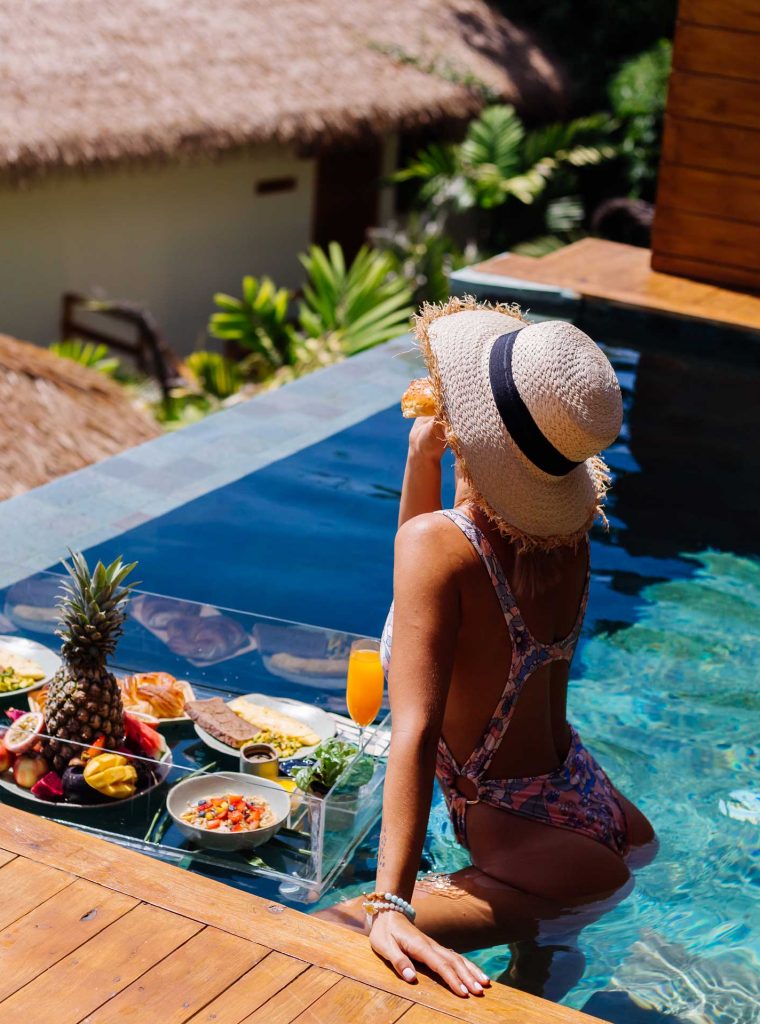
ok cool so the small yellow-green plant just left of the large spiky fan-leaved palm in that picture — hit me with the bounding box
[209,275,293,376]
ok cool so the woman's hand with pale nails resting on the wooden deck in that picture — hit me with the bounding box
[370,910,490,998]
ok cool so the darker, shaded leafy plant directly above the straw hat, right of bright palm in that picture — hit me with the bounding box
[371,210,477,307]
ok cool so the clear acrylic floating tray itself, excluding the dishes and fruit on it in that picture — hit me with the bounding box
[0,581,390,902]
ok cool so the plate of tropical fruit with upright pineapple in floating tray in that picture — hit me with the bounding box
[0,554,171,809]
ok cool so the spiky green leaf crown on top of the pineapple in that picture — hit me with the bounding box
[55,551,137,666]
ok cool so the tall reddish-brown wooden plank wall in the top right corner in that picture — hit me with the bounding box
[651,0,760,292]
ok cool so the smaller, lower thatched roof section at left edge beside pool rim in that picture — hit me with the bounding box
[0,335,161,499]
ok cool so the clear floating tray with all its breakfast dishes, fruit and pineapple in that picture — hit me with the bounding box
[0,554,390,900]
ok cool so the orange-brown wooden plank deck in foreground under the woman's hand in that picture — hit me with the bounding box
[0,804,594,1024]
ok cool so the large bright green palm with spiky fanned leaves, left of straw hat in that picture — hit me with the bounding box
[298,242,413,355]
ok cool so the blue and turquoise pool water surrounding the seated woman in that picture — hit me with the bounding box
[83,337,760,1024]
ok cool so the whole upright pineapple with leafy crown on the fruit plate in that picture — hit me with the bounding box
[43,553,136,773]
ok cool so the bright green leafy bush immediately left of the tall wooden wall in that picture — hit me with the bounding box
[609,39,673,200]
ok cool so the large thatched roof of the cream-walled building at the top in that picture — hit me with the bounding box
[0,0,562,177]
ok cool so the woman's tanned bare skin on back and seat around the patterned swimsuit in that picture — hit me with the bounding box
[434,511,653,901]
